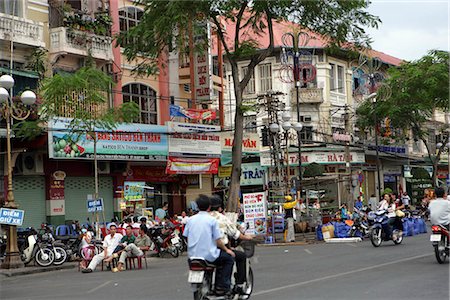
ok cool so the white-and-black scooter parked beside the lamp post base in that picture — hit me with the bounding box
[17,227,55,267]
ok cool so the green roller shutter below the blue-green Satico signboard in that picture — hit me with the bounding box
[64,177,113,223]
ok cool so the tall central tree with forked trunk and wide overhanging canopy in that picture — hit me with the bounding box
[118,0,380,212]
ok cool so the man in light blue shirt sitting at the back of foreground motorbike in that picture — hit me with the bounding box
[183,195,234,294]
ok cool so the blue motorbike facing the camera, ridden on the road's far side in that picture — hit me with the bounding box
[370,210,403,247]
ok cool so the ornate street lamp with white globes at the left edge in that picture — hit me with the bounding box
[0,75,36,269]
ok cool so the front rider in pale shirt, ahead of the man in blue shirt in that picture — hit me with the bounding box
[210,195,253,292]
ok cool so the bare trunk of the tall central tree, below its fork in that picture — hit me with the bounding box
[227,86,244,212]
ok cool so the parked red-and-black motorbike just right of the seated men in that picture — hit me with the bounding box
[148,223,180,257]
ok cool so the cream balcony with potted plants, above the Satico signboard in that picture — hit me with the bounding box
[50,27,113,61]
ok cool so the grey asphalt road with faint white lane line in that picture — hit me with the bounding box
[0,234,449,300]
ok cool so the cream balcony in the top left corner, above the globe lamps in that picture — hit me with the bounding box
[0,13,45,47]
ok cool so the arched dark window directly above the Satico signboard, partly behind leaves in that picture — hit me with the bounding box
[122,83,158,124]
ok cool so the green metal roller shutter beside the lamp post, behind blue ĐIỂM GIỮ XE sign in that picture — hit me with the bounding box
[13,176,47,228]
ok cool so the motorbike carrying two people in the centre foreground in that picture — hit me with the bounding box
[188,241,255,300]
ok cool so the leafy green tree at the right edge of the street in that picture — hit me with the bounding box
[356,50,450,185]
